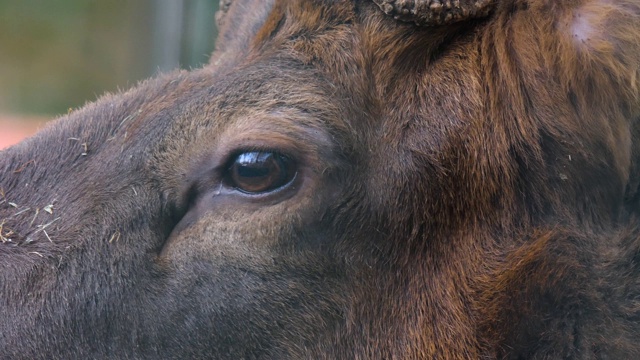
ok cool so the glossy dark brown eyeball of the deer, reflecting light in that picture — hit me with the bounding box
[228,151,296,194]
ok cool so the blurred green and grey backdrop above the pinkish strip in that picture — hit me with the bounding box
[0,0,218,117]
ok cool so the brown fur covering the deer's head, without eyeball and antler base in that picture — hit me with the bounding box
[0,0,640,359]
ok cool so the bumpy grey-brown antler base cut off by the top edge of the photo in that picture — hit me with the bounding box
[373,0,496,26]
